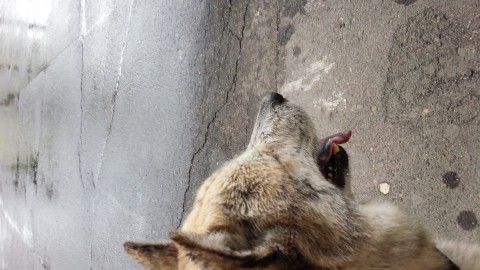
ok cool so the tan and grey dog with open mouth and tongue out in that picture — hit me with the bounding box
[124,93,480,270]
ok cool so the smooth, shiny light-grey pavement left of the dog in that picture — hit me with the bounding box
[0,0,205,269]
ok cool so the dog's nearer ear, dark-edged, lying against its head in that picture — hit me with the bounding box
[170,231,278,269]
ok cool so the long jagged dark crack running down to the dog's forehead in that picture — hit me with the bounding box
[177,0,251,229]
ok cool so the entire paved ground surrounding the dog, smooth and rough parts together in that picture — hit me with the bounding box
[0,0,480,269]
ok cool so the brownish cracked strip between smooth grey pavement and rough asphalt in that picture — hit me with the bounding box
[180,1,276,219]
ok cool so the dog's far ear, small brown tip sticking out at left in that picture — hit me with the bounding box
[123,242,178,270]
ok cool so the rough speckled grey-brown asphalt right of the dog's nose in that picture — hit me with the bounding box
[278,1,480,243]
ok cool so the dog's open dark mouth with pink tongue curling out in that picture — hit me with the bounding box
[315,130,352,188]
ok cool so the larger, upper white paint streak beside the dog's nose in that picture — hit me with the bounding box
[281,58,335,93]
